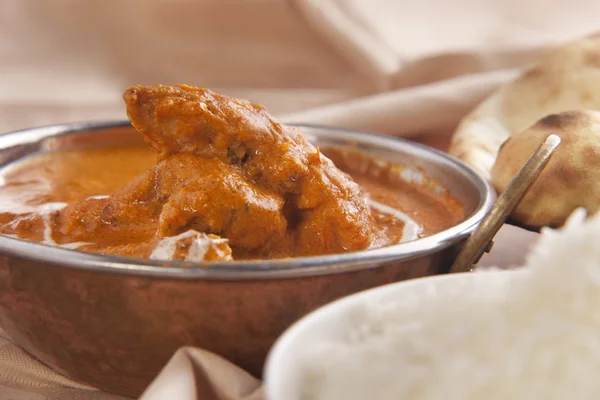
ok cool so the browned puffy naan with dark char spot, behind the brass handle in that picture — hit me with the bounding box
[491,111,600,228]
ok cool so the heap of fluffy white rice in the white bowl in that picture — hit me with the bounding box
[302,210,600,400]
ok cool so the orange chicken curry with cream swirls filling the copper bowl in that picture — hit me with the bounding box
[0,85,464,261]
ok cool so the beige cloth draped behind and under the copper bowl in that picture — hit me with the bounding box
[0,0,600,400]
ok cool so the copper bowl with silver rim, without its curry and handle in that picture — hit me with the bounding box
[0,121,495,396]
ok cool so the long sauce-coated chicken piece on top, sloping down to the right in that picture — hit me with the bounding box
[124,85,379,255]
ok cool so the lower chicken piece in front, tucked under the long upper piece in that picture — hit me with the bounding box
[58,153,286,254]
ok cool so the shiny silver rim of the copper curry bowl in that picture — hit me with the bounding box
[0,120,496,280]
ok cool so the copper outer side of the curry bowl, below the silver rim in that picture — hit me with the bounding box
[0,246,456,396]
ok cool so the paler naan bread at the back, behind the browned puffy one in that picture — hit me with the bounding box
[449,35,600,180]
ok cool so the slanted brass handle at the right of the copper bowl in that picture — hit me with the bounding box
[450,134,560,273]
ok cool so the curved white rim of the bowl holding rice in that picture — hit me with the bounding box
[263,269,529,400]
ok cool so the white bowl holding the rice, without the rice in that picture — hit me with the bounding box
[264,271,521,400]
